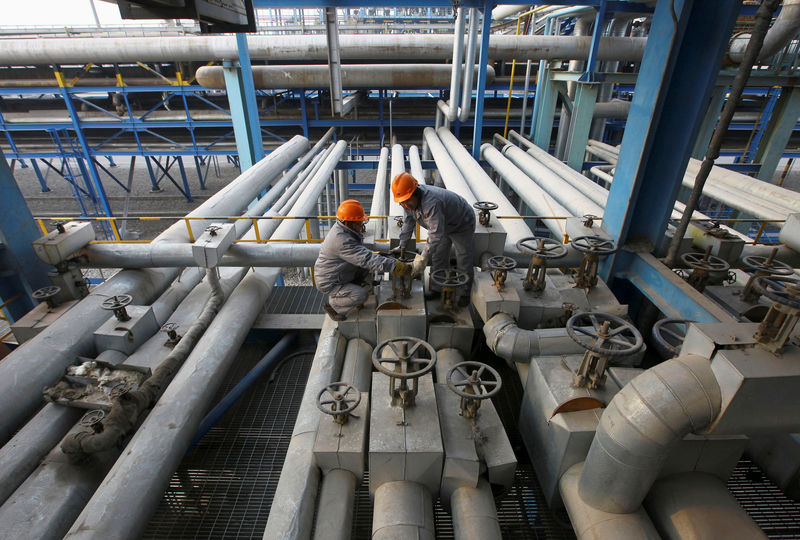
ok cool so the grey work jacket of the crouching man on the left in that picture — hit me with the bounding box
[314,221,396,294]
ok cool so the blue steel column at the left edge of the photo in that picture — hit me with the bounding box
[0,150,51,320]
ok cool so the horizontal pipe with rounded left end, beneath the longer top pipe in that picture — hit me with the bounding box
[197,64,495,89]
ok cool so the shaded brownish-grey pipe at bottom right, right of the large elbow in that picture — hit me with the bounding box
[644,472,767,540]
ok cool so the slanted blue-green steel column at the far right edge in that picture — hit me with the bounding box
[755,86,800,182]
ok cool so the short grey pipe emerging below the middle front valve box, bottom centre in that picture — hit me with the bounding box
[372,480,436,540]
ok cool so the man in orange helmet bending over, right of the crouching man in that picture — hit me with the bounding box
[392,172,475,307]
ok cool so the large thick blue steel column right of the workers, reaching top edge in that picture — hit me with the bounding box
[600,0,741,316]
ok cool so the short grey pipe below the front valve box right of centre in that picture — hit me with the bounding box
[450,477,503,540]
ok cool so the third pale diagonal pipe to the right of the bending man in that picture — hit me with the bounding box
[481,143,573,239]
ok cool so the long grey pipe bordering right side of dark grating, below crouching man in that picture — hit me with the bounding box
[264,317,347,540]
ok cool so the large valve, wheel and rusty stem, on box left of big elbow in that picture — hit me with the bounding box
[567,312,644,388]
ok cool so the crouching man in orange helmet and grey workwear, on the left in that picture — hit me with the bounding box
[314,199,411,321]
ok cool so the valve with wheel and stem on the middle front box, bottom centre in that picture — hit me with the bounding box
[372,336,436,409]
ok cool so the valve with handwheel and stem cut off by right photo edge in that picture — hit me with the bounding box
[753,276,800,353]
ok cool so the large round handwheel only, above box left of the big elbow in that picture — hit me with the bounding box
[567,313,644,356]
